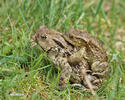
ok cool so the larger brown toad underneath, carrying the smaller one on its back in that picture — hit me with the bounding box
[32,26,101,88]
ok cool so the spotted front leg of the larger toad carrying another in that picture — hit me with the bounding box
[55,57,72,88]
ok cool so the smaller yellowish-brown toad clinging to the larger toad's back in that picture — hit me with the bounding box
[63,29,108,77]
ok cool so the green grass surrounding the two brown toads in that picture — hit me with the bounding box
[0,0,125,100]
